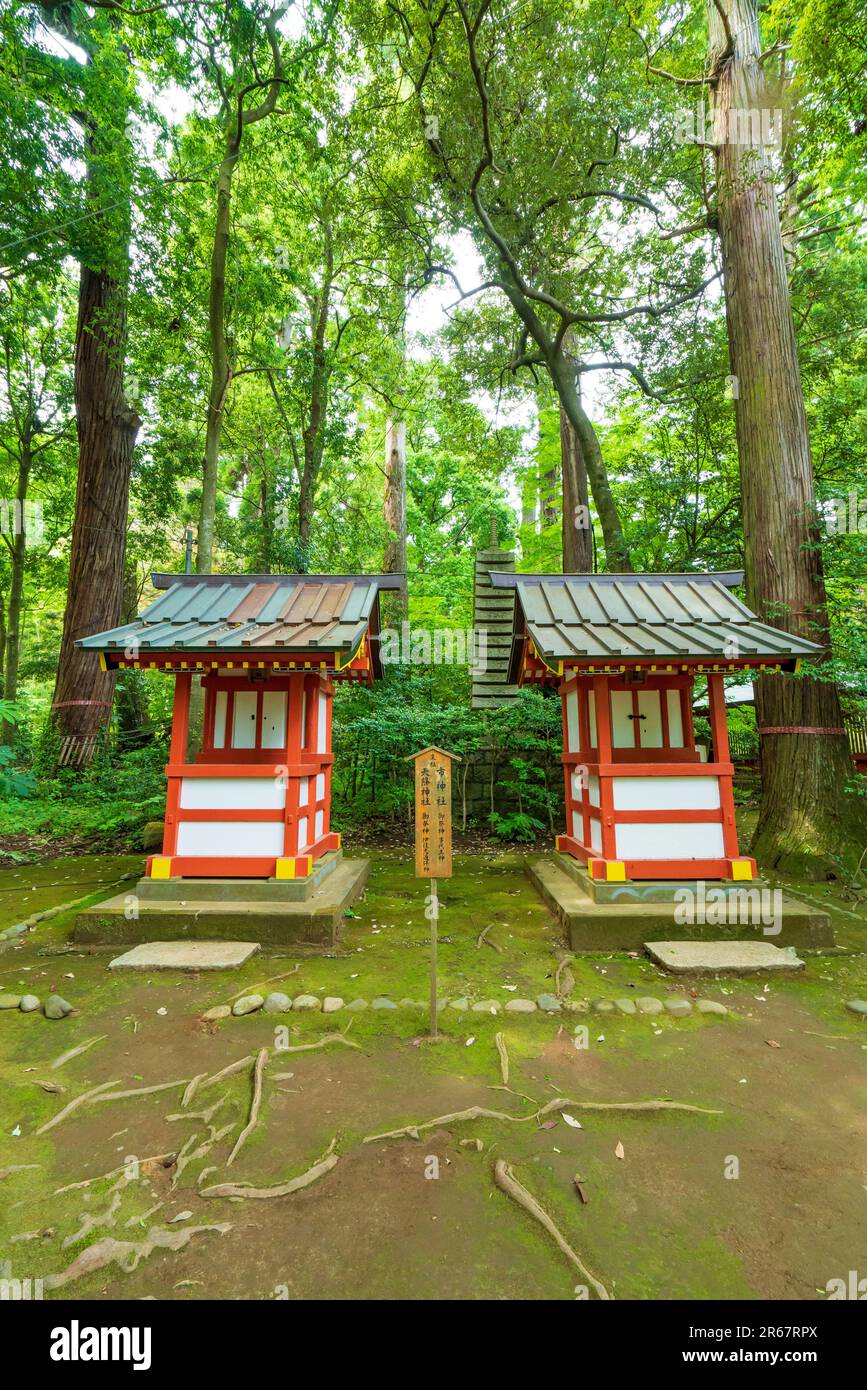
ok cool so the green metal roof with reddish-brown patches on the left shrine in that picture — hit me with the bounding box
[75,574,404,669]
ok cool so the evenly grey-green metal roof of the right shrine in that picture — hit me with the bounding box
[490,573,823,669]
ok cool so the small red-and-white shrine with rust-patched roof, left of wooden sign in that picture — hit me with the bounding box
[78,574,404,878]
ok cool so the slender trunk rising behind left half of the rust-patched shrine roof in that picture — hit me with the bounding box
[196,154,238,574]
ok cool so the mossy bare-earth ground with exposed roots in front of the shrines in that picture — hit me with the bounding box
[0,853,867,1300]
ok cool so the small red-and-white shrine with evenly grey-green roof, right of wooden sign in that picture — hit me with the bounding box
[490,573,821,881]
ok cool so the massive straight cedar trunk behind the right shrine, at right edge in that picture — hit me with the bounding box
[707,0,854,872]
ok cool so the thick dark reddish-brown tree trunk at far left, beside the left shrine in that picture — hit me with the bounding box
[53,255,140,737]
